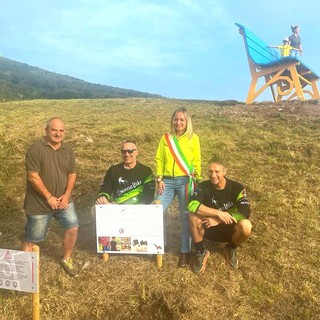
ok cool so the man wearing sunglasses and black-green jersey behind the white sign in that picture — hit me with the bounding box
[96,140,155,204]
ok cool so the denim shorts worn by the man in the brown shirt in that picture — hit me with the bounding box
[25,202,79,243]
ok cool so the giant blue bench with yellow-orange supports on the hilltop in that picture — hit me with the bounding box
[236,23,319,104]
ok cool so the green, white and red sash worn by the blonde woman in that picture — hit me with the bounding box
[164,133,195,201]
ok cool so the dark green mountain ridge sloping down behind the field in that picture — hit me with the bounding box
[0,57,161,100]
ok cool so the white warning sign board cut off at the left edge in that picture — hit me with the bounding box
[0,249,38,293]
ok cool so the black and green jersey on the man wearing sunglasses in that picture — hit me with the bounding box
[99,162,155,204]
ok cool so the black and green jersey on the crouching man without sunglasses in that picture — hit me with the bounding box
[188,178,251,221]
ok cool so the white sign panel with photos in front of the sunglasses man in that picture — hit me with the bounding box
[95,204,164,254]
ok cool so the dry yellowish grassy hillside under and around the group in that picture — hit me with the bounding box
[0,99,320,320]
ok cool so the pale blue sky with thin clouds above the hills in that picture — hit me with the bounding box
[0,0,320,101]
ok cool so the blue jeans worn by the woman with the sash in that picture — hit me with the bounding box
[156,177,191,253]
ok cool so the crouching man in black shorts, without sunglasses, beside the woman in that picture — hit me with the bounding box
[188,159,252,274]
